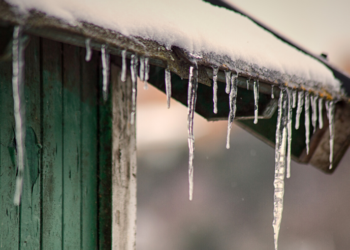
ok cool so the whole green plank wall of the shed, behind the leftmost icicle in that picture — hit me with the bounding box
[0,37,111,250]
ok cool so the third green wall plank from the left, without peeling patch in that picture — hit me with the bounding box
[41,39,63,250]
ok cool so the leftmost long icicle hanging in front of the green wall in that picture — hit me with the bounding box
[12,26,26,206]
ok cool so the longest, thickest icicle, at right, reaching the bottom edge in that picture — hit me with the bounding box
[272,90,288,250]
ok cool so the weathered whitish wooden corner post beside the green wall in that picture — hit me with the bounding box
[111,64,137,250]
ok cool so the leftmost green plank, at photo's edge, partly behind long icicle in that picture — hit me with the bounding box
[0,55,19,250]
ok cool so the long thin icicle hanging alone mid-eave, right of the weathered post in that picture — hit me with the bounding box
[187,62,198,200]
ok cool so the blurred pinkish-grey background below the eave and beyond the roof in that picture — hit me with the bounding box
[137,0,350,250]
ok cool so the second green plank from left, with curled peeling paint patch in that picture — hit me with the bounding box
[20,37,41,249]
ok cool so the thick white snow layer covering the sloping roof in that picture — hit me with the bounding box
[5,0,341,93]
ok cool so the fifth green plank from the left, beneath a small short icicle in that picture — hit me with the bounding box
[81,52,98,250]
